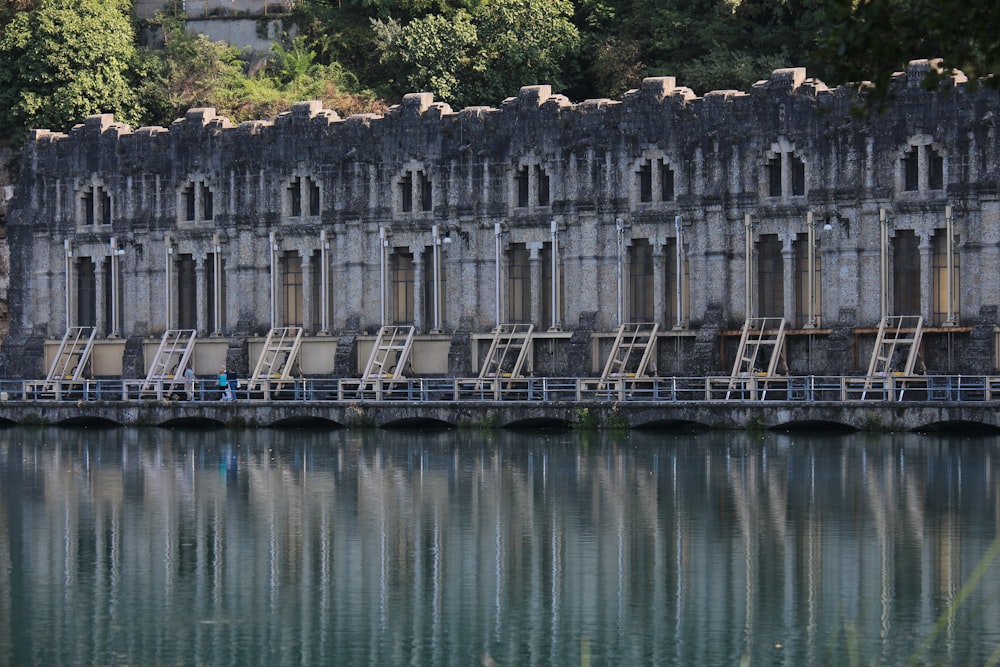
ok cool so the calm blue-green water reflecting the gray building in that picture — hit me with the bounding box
[0,429,1000,666]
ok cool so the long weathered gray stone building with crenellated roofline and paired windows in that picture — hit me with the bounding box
[0,61,1000,377]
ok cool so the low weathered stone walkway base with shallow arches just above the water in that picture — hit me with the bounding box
[0,397,1000,432]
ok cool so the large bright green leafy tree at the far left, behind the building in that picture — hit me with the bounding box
[0,0,143,141]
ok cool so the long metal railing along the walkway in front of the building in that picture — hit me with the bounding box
[0,375,1000,402]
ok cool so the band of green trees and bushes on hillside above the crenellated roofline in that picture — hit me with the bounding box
[0,0,1000,143]
